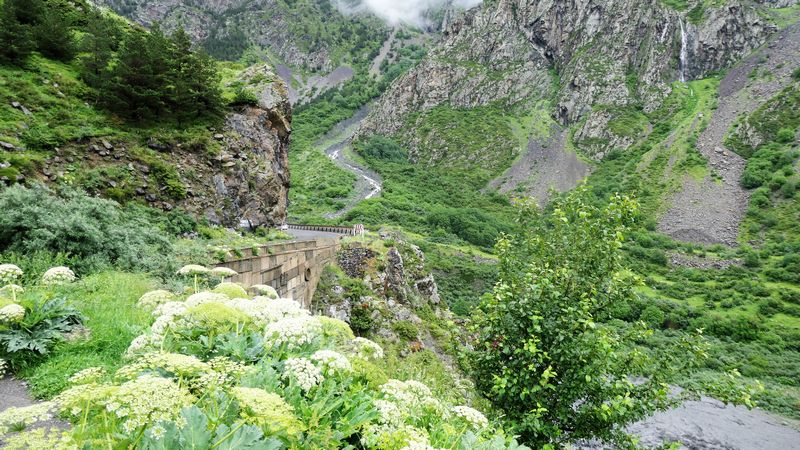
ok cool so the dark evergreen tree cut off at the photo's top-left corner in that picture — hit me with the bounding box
[0,0,36,64]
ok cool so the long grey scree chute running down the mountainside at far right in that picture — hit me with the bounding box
[658,24,800,246]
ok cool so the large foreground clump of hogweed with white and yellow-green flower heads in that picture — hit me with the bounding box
[6,282,520,450]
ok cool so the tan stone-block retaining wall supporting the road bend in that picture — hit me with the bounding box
[217,225,360,308]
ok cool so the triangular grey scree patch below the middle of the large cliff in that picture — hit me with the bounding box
[489,128,590,204]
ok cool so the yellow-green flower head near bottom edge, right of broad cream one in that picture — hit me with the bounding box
[231,387,303,436]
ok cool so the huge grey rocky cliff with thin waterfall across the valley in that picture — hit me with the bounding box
[360,0,775,157]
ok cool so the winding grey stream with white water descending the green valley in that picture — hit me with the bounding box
[319,106,383,219]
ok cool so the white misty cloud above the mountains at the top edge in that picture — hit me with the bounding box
[334,0,482,26]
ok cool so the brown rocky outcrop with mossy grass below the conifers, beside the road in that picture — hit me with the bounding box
[34,66,292,227]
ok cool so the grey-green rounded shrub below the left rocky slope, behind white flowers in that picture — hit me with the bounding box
[0,186,175,272]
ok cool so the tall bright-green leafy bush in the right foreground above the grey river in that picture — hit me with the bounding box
[472,188,752,448]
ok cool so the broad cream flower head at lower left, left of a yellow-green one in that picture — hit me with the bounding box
[106,375,195,433]
